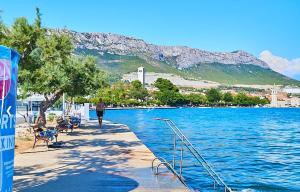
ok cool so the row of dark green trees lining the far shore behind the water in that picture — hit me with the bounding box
[88,79,268,106]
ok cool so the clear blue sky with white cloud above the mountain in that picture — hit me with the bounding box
[0,0,300,79]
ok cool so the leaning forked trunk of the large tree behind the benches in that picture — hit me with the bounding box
[37,90,63,125]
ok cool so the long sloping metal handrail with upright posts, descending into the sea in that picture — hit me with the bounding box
[152,118,232,192]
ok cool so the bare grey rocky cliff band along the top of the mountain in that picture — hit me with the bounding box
[55,30,269,69]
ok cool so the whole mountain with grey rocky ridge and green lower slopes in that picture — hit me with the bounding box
[56,30,300,86]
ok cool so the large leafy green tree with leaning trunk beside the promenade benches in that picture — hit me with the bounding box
[4,9,99,122]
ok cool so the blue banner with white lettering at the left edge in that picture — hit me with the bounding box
[0,46,19,192]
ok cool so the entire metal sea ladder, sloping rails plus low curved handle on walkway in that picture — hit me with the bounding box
[152,118,232,192]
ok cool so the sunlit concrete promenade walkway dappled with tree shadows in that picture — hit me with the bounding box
[14,122,188,192]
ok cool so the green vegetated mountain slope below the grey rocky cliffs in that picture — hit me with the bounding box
[77,49,300,86]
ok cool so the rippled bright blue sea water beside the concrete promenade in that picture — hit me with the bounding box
[91,108,300,192]
